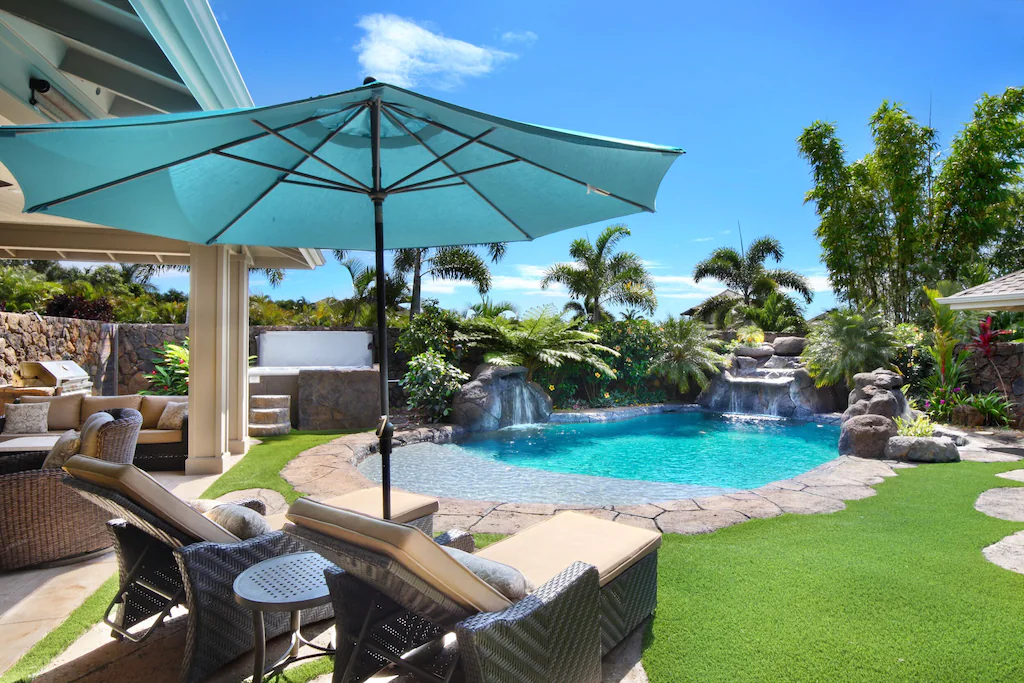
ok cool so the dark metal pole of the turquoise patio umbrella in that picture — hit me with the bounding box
[370,89,394,519]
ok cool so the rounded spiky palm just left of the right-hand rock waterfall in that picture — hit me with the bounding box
[650,315,725,393]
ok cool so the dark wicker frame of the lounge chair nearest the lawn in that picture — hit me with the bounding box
[285,518,657,683]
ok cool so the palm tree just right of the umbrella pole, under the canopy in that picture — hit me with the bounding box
[394,242,507,319]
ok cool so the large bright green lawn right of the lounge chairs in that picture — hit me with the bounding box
[643,463,1024,683]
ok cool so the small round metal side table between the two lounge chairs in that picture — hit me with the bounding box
[234,553,334,683]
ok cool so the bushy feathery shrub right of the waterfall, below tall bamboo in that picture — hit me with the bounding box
[802,307,893,387]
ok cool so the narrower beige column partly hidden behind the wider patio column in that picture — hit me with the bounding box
[227,250,249,455]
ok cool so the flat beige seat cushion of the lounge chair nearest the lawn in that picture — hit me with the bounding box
[476,512,662,586]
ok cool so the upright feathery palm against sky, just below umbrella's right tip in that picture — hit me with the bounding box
[541,225,657,324]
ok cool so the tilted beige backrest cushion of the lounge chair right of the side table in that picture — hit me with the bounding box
[287,498,512,612]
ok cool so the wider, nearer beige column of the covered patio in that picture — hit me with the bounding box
[185,245,232,474]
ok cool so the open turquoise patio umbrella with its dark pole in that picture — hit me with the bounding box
[0,79,682,517]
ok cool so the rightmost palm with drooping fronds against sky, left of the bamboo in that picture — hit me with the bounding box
[693,237,814,327]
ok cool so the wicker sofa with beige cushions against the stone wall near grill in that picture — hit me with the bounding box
[0,394,188,471]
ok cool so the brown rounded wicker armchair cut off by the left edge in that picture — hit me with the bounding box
[0,409,142,571]
